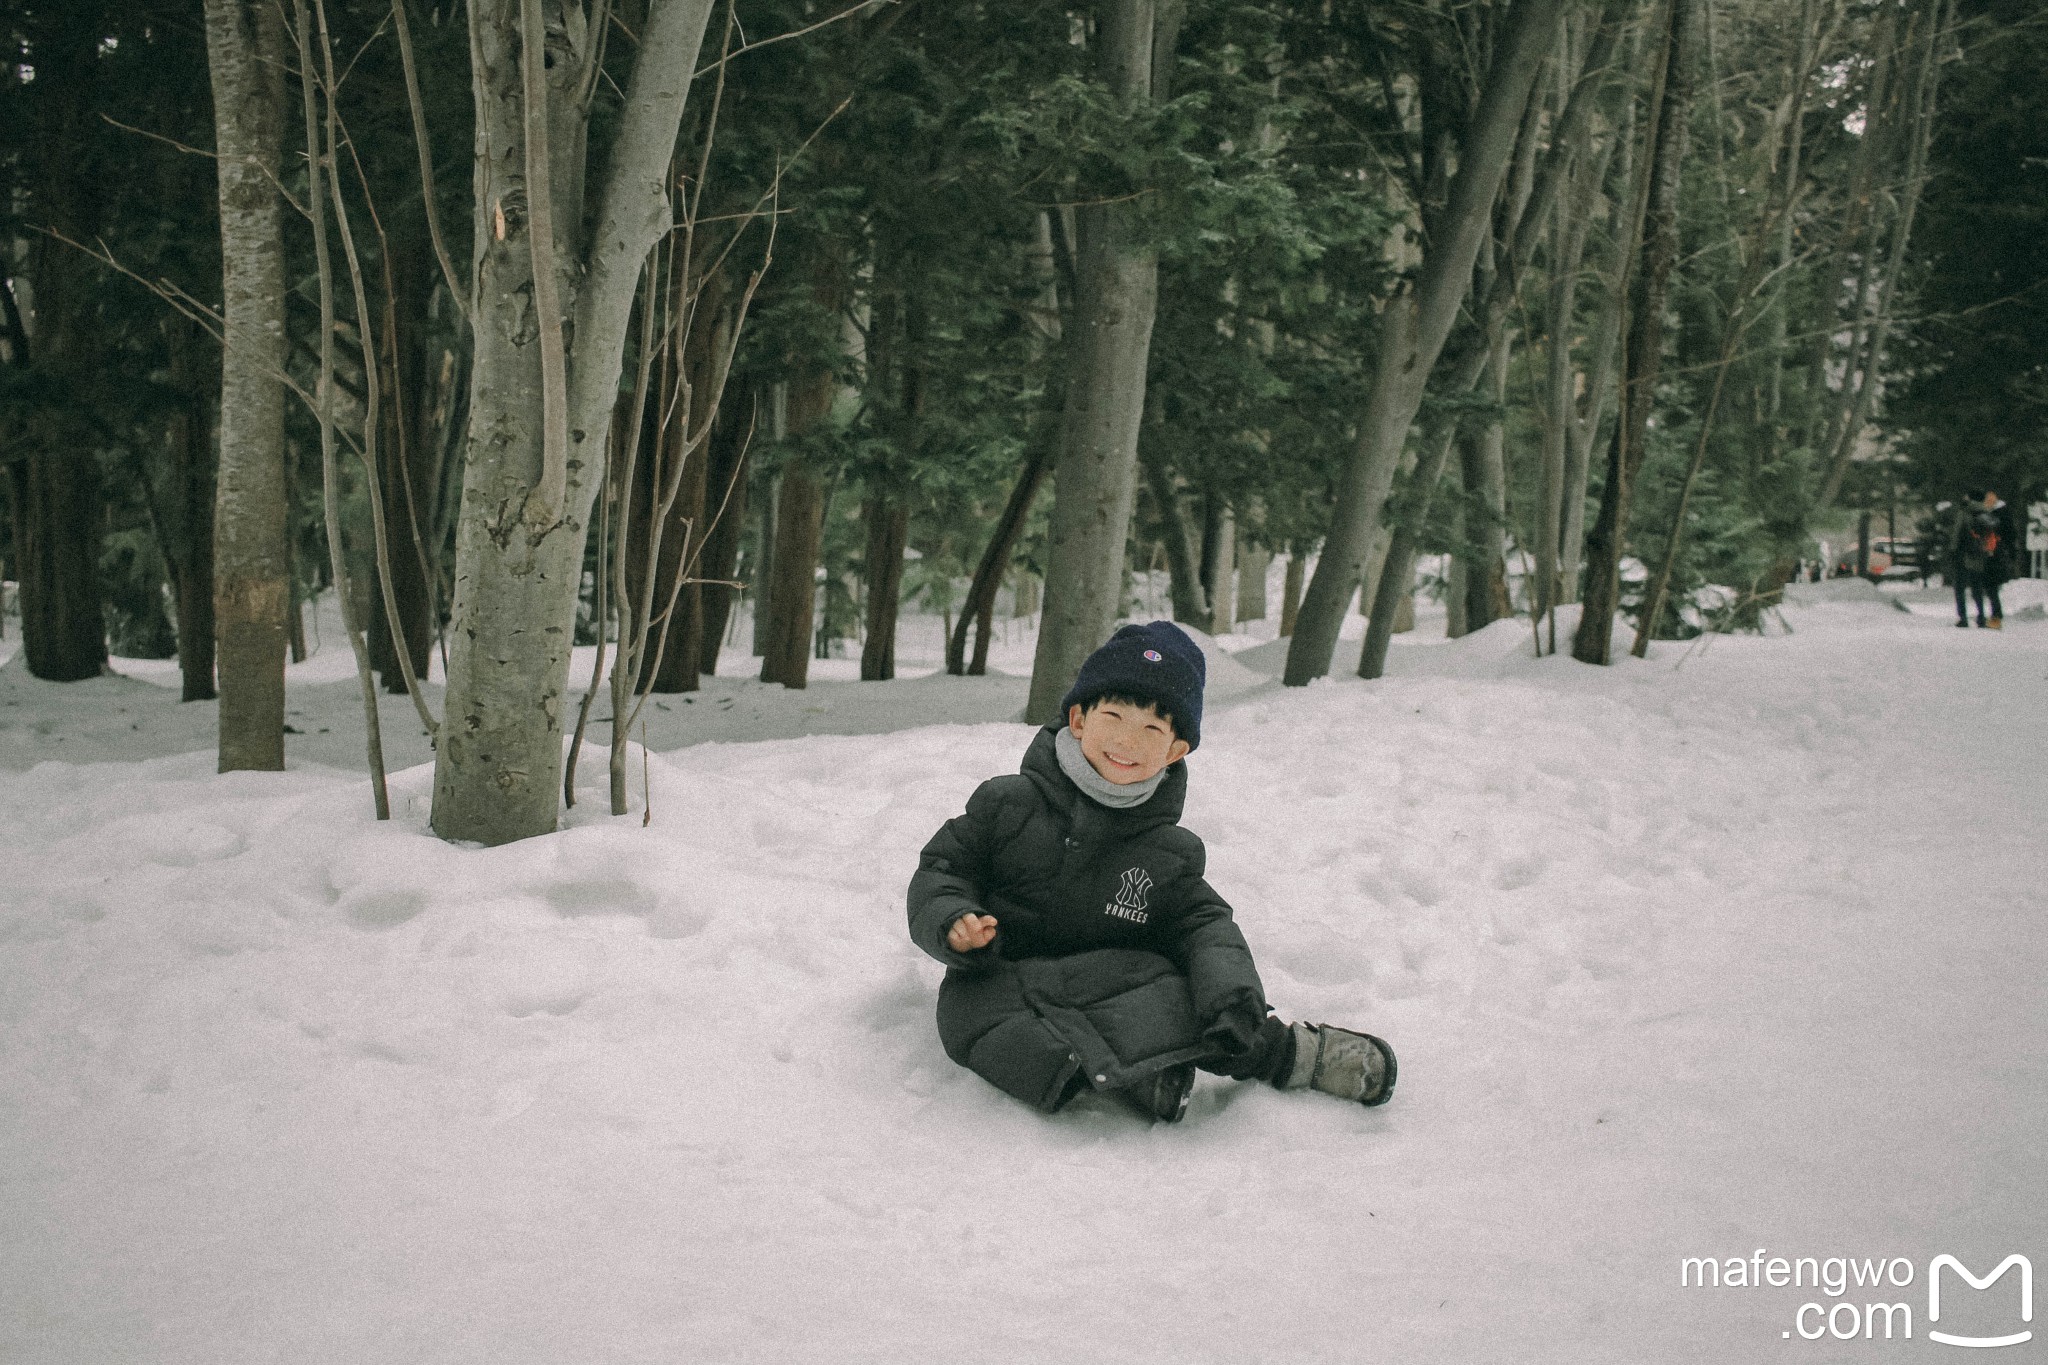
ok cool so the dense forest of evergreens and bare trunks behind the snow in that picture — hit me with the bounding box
[0,0,2048,843]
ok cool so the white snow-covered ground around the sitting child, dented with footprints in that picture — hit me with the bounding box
[0,583,2048,1365]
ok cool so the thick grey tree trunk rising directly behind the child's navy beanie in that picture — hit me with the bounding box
[1024,0,1184,724]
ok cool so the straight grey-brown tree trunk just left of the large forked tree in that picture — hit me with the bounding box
[207,0,291,772]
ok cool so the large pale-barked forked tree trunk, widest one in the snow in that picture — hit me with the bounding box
[434,0,711,845]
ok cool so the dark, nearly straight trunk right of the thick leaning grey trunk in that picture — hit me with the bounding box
[1571,0,1700,663]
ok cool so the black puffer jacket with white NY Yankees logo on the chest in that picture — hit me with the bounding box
[909,724,1266,1111]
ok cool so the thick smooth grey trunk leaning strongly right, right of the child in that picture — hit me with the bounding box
[1282,0,1565,688]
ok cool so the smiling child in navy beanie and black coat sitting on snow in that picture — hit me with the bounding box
[909,620,1395,1124]
